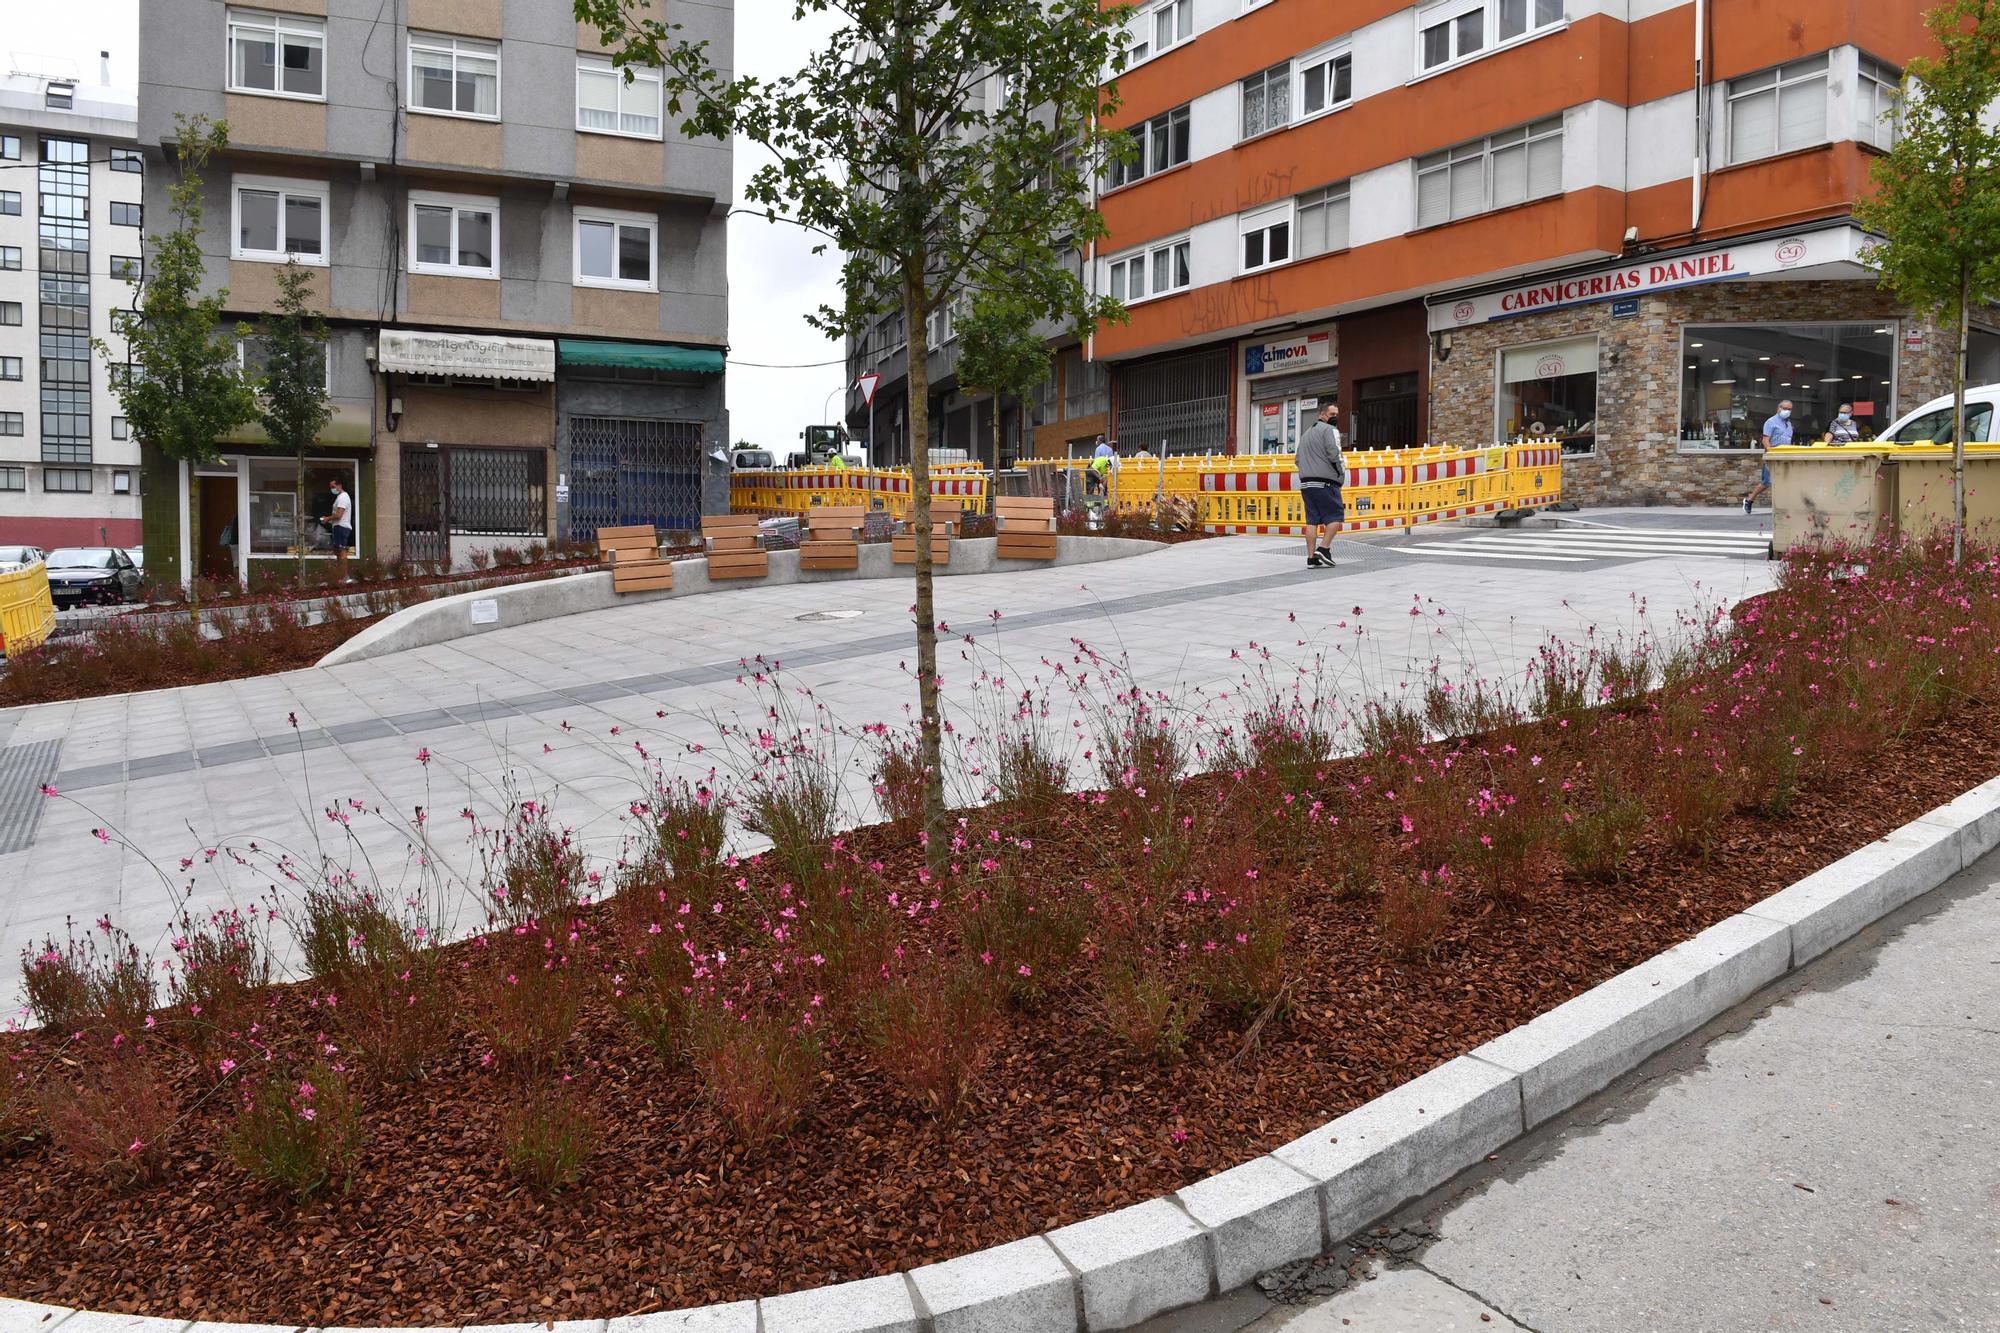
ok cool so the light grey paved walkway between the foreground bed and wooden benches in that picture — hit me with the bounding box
[0,510,1772,1003]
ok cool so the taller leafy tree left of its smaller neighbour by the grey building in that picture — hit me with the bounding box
[94,116,258,606]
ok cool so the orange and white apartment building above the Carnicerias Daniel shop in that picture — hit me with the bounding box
[868,0,1976,502]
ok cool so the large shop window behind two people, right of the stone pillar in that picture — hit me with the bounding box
[1680,322,1896,450]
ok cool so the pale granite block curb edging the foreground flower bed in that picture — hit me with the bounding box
[0,779,2000,1333]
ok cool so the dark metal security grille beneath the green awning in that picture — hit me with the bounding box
[570,416,702,542]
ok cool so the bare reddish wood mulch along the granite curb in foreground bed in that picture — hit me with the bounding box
[0,707,2000,1325]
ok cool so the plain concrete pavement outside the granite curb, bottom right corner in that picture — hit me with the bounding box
[1146,840,2000,1333]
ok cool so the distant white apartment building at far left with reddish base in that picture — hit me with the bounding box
[0,65,144,548]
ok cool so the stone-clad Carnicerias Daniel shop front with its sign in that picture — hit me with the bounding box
[1428,224,1950,504]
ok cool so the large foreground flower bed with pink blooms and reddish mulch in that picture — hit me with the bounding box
[0,532,2000,1325]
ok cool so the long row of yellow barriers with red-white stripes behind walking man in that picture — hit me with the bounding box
[730,444,1562,534]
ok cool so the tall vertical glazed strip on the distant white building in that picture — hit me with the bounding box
[36,138,90,462]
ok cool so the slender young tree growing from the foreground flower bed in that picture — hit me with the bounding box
[574,0,1130,844]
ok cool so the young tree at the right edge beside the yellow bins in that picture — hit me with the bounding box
[1854,0,2000,562]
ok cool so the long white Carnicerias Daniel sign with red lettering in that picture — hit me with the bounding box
[1430,226,1868,332]
